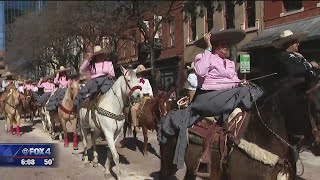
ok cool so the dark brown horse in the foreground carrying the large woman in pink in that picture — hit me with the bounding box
[160,85,302,180]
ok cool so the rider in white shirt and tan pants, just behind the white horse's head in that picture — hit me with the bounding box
[131,64,153,132]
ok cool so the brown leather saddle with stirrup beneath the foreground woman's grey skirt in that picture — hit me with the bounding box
[188,108,248,177]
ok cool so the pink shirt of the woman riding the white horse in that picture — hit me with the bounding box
[80,60,115,79]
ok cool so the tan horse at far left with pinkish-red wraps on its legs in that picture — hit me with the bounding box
[4,89,25,136]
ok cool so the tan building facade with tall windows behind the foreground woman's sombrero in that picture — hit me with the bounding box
[184,1,264,81]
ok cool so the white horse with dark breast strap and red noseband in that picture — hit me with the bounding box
[79,66,141,179]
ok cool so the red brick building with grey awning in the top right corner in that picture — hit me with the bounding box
[243,0,320,59]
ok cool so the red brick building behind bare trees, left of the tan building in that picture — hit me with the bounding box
[116,1,184,90]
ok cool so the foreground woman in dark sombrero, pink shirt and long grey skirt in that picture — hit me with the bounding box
[158,29,263,169]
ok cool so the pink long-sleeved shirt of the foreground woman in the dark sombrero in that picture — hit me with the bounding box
[194,50,240,90]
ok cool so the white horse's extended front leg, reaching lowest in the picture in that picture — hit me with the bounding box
[102,130,121,180]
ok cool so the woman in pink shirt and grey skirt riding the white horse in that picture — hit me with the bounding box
[73,46,115,110]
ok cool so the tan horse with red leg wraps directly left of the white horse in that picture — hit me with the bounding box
[49,80,80,150]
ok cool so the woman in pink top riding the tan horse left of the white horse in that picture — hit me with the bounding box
[46,66,71,111]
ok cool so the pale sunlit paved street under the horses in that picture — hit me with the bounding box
[0,116,320,180]
